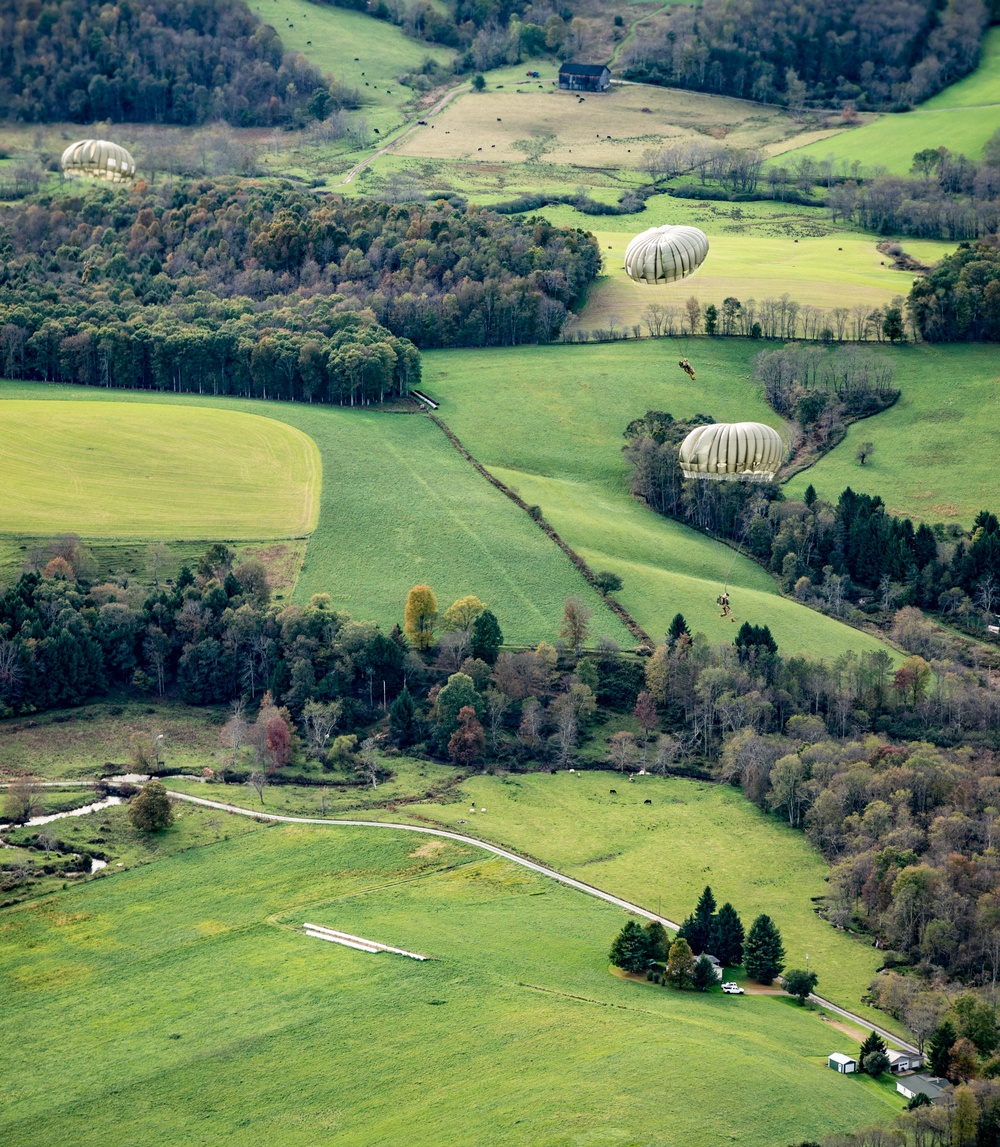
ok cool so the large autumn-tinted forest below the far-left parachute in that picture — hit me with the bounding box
[0,179,601,404]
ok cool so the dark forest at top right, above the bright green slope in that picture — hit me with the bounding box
[623,0,987,110]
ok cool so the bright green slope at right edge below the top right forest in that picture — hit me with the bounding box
[774,28,1000,175]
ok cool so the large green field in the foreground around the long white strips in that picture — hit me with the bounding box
[0,826,898,1147]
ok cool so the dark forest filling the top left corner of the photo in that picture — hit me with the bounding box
[0,0,327,126]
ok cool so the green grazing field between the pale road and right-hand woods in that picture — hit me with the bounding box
[180,766,893,1027]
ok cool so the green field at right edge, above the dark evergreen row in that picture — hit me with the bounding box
[788,344,1000,526]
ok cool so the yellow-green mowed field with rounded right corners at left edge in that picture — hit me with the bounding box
[0,398,322,539]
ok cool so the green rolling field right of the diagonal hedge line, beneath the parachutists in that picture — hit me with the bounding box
[423,338,880,658]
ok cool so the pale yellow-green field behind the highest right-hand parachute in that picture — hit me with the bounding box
[561,225,955,334]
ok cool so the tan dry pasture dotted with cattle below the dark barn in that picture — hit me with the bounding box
[396,76,834,168]
